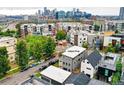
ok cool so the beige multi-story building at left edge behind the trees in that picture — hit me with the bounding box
[0,37,17,62]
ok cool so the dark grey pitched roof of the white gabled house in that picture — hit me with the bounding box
[86,50,102,68]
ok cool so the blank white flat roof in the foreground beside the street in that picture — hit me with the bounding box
[41,66,71,83]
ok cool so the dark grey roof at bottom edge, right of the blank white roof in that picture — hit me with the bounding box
[72,72,91,85]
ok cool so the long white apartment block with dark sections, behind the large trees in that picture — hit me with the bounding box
[21,24,55,36]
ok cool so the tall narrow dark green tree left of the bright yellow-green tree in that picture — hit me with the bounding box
[16,40,28,70]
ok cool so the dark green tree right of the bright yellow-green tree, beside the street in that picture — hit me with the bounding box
[42,37,56,59]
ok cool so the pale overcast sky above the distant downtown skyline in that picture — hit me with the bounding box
[0,7,120,15]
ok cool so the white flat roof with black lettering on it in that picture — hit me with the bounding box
[62,46,86,58]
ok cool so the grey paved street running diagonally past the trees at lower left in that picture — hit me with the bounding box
[0,58,56,85]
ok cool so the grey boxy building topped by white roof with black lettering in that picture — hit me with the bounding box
[59,46,87,72]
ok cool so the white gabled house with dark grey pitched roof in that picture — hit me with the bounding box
[81,50,102,78]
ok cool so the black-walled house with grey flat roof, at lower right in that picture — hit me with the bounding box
[97,52,121,82]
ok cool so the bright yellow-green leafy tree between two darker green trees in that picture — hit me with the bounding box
[26,36,47,61]
